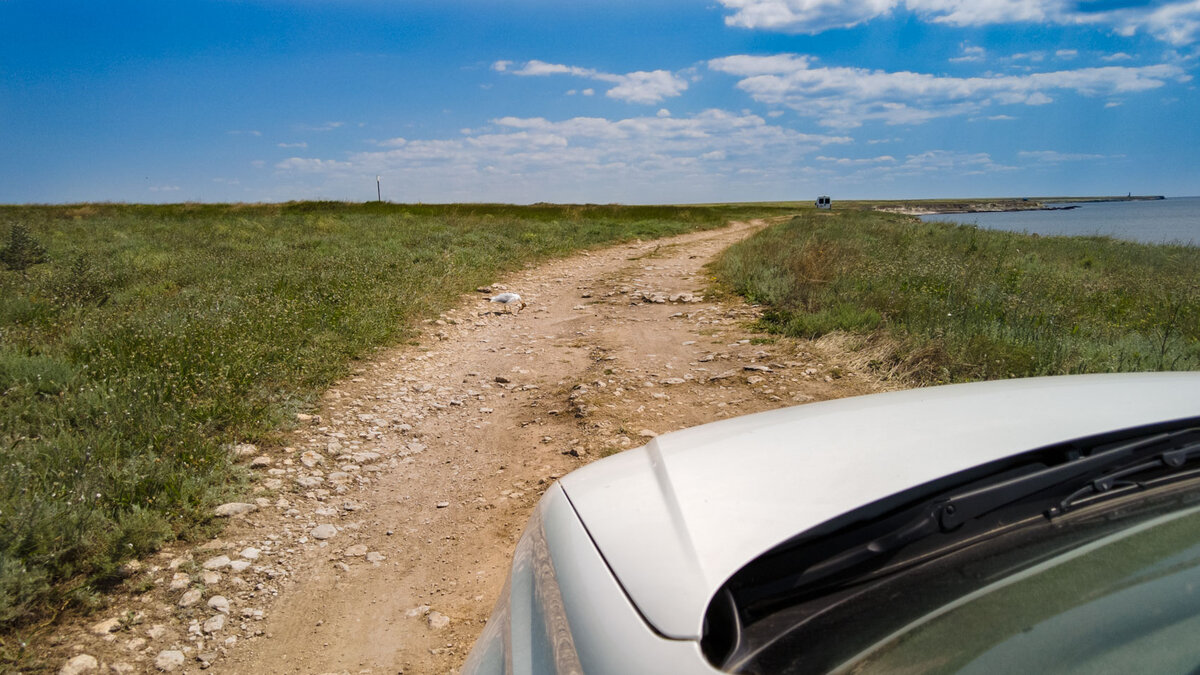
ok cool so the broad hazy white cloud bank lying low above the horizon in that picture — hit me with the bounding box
[275,109,851,202]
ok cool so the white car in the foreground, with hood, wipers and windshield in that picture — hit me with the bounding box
[463,372,1200,675]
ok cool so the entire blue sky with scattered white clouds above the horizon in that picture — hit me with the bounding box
[0,0,1200,203]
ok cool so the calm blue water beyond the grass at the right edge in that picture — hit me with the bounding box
[922,197,1200,246]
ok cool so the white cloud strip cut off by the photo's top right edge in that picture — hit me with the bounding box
[719,0,1200,46]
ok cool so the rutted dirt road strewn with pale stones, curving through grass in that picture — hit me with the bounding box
[49,222,882,674]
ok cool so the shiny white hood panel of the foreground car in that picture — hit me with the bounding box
[562,372,1200,639]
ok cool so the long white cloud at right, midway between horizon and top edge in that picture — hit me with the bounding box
[708,54,1190,129]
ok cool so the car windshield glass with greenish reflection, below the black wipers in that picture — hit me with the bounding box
[838,497,1200,674]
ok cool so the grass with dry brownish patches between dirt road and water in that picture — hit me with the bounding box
[714,210,1200,383]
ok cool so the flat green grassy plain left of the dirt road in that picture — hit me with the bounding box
[0,203,770,634]
